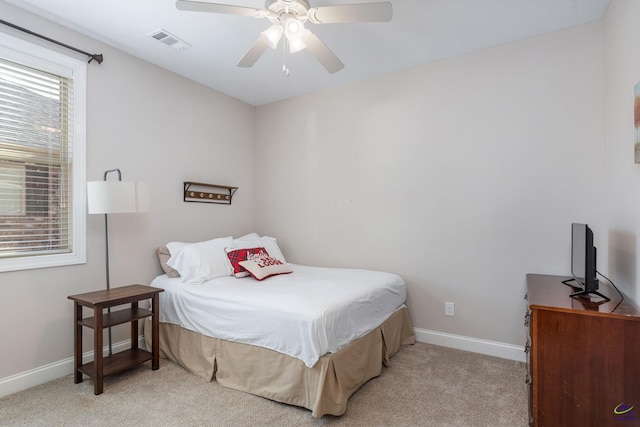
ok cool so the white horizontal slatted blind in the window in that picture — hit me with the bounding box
[0,58,74,258]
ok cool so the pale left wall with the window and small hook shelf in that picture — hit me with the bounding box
[0,2,255,382]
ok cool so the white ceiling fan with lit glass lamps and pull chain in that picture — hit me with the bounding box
[176,0,393,75]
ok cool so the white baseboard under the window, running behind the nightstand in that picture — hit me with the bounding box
[0,335,145,397]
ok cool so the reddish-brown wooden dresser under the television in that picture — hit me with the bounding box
[525,274,640,427]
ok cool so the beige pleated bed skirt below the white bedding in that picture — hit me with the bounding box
[144,307,415,417]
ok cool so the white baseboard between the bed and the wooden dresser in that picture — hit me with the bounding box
[413,328,526,362]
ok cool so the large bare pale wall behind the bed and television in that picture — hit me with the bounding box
[256,23,604,345]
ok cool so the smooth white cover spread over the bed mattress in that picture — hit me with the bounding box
[151,264,406,367]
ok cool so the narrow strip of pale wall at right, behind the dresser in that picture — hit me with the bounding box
[602,0,640,302]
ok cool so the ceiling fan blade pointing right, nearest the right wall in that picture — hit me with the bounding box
[309,1,393,24]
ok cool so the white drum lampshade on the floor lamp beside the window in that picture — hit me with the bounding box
[87,181,149,214]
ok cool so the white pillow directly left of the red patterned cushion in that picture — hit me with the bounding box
[167,237,234,284]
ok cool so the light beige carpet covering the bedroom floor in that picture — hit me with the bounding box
[0,343,528,427]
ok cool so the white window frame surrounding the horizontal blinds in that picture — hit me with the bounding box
[0,32,87,272]
